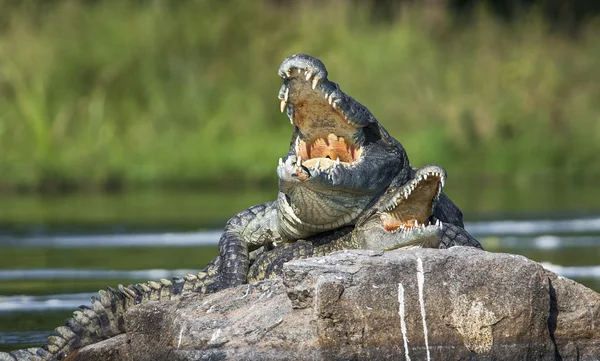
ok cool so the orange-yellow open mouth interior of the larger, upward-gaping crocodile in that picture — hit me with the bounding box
[279,67,364,169]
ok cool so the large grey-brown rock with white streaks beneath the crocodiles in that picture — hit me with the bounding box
[70,247,600,361]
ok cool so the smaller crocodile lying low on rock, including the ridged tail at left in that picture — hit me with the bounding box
[0,166,481,361]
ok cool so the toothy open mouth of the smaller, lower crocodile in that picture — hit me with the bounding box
[379,166,446,232]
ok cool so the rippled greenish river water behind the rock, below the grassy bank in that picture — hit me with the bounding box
[0,188,600,350]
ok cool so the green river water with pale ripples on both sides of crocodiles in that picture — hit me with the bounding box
[0,184,600,350]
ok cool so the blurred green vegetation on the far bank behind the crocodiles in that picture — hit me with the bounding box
[0,0,600,190]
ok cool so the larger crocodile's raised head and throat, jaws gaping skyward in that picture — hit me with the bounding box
[277,54,410,239]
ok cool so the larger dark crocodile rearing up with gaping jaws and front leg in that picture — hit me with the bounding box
[213,54,464,289]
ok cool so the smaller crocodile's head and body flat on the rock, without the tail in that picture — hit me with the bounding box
[247,165,482,283]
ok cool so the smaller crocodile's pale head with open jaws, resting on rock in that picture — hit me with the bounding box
[352,165,446,250]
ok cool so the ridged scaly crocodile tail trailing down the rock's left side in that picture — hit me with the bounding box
[0,257,220,361]
